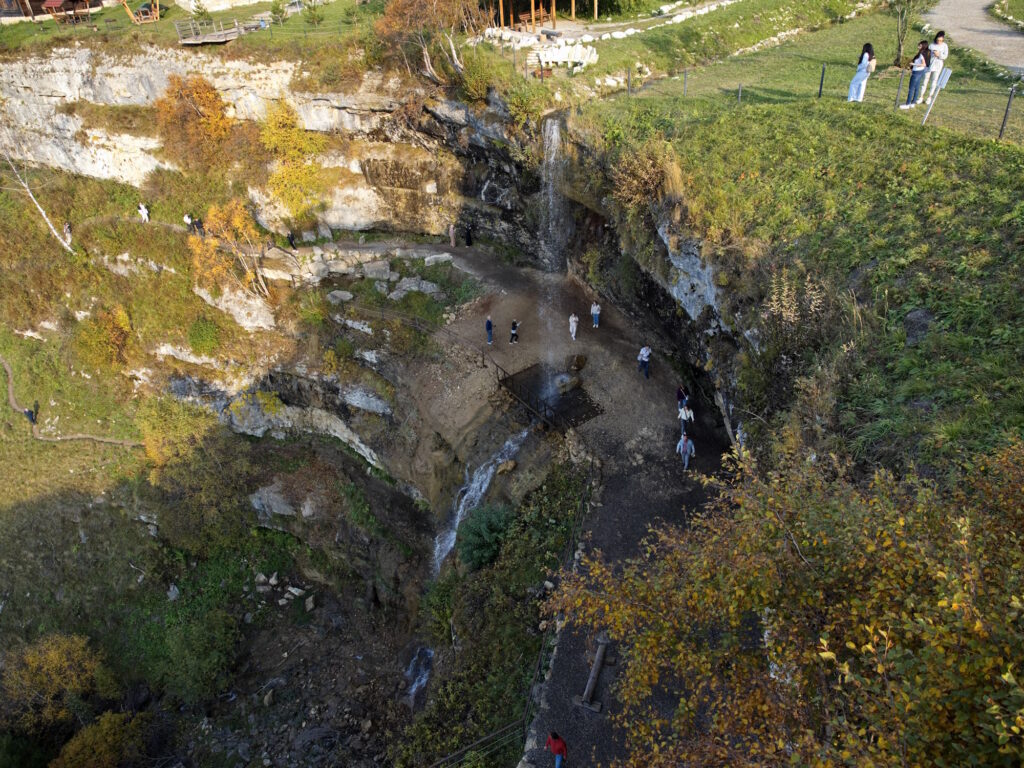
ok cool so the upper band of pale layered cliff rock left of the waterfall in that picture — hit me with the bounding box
[0,45,536,252]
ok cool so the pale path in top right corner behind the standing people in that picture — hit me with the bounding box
[925,0,1024,76]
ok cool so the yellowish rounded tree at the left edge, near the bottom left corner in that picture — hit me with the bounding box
[0,635,100,731]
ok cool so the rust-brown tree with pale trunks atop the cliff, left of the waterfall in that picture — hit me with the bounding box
[376,0,487,85]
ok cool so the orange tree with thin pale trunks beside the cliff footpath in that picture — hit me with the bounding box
[188,198,269,297]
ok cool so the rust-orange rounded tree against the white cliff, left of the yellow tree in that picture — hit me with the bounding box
[154,75,234,171]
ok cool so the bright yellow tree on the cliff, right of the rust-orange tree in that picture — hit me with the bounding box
[260,101,326,218]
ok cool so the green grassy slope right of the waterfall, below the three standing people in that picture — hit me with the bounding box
[578,10,1024,464]
